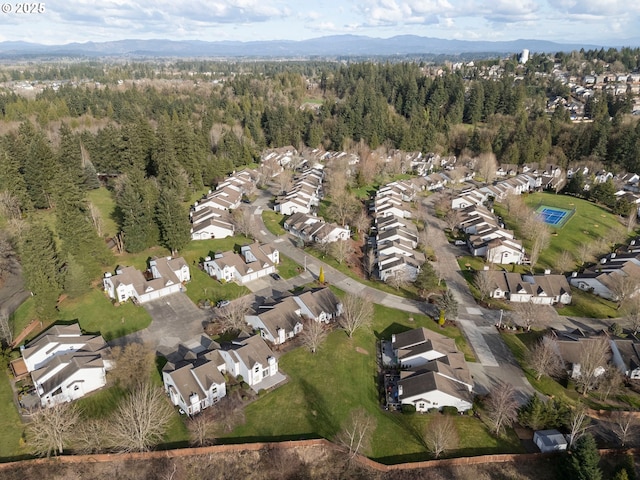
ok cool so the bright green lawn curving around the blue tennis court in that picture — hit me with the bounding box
[523,193,624,268]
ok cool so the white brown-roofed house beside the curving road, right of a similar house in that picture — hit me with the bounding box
[203,242,280,285]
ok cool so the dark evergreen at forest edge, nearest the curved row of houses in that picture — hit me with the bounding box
[156,188,191,254]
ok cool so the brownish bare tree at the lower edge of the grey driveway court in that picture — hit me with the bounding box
[109,343,156,390]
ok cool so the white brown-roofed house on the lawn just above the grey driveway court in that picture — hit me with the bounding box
[102,257,191,303]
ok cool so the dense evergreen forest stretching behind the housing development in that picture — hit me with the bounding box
[0,49,640,317]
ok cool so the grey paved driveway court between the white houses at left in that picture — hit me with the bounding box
[110,293,209,353]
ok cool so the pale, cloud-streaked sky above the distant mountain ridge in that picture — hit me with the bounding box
[0,0,640,45]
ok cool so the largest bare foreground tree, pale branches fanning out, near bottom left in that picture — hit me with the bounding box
[107,382,174,452]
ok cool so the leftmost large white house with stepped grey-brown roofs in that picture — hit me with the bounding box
[21,323,113,407]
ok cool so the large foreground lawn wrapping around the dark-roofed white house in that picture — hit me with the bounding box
[227,300,510,463]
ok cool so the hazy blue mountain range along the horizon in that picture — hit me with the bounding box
[0,35,639,58]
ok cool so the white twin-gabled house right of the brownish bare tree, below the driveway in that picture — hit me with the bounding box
[162,345,227,416]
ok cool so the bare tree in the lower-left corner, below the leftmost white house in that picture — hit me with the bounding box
[27,403,80,457]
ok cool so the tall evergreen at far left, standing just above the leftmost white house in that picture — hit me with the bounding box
[20,224,62,319]
